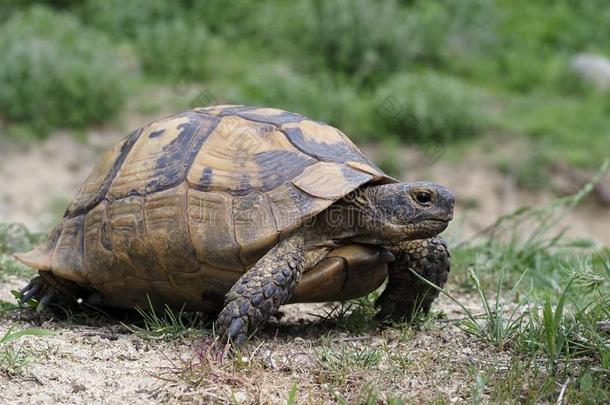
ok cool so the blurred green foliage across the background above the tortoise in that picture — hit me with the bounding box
[0,0,610,167]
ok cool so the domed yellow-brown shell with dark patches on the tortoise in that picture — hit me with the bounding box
[18,105,395,310]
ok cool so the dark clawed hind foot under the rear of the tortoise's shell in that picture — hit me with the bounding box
[19,271,82,312]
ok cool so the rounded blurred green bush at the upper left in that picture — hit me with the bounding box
[0,6,124,134]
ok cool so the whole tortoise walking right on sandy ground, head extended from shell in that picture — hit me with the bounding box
[16,105,454,344]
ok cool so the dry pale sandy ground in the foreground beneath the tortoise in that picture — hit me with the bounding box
[0,279,498,404]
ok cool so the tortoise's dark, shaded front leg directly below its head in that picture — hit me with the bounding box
[375,238,450,321]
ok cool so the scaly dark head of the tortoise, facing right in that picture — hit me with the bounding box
[352,182,454,244]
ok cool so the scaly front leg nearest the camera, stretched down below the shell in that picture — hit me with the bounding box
[216,233,305,345]
